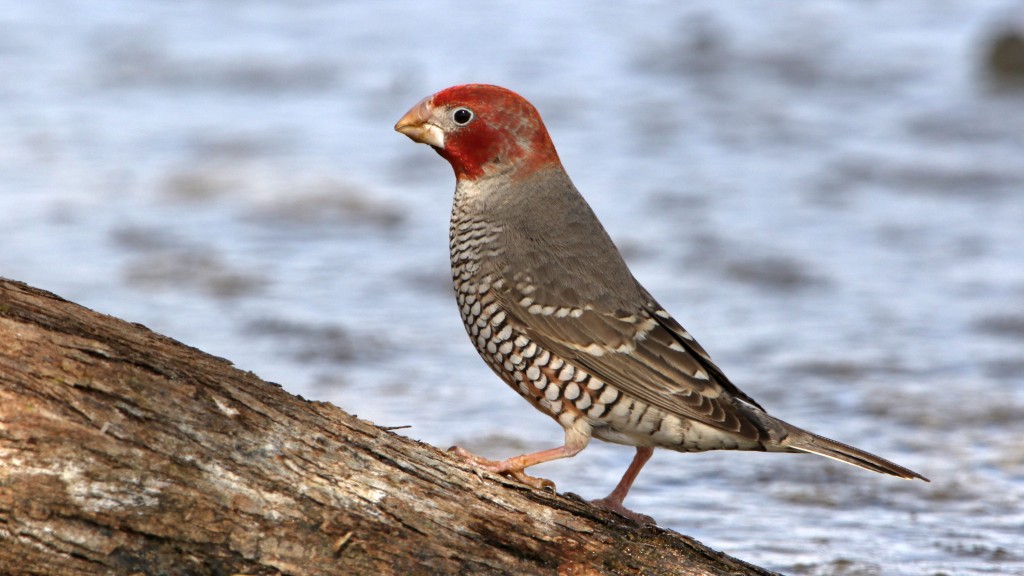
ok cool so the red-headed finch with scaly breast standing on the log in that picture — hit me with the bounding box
[394,84,929,524]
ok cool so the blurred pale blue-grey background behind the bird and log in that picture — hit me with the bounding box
[0,0,1024,575]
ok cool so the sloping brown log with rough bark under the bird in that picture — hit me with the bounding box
[0,279,770,576]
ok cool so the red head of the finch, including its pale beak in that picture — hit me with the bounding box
[394,84,559,179]
